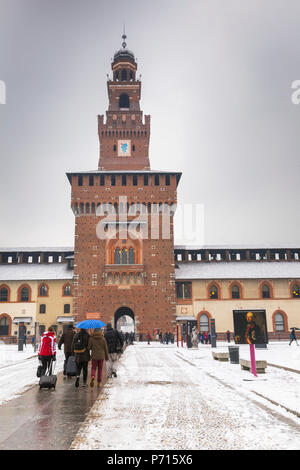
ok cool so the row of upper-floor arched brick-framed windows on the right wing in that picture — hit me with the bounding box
[207,281,300,299]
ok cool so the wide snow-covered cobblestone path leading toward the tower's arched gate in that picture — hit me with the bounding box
[72,345,300,450]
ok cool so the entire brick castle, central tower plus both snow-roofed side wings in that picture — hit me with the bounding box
[0,35,300,341]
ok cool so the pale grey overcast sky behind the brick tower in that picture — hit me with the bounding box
[0,0,300,247]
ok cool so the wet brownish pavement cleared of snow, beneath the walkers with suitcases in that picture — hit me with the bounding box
[0,373,99,450]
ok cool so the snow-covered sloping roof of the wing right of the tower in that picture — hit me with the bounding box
[175,261,300,280]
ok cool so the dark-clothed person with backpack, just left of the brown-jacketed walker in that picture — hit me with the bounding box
[72,329,91,387]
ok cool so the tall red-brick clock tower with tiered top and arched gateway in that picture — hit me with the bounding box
[67,34,181,334]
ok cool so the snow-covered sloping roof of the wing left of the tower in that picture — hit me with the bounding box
[0,263,73,281]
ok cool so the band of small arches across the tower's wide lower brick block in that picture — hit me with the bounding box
[72,202,176,217]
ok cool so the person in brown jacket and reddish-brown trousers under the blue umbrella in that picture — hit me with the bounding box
[88,328,108,388]
